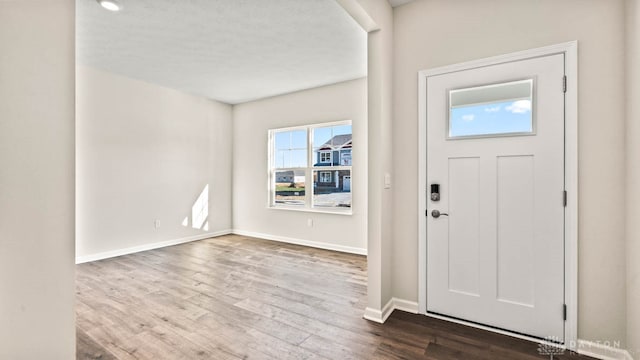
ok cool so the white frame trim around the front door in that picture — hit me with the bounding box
[418,41,578,350]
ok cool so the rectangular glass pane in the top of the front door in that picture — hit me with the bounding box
[448,79,533,138]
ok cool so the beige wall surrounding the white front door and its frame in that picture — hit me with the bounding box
[392,0,627,346]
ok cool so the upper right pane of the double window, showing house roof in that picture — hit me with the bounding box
[313,125,353,166]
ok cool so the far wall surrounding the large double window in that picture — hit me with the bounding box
[233,79,367,251]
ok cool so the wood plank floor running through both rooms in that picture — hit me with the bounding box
[76,235,588,360]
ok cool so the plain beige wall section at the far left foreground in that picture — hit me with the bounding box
[0,0,75,360]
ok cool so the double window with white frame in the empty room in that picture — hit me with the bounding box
[269,120,352,213]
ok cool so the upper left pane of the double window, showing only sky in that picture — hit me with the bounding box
[273,130,307,169]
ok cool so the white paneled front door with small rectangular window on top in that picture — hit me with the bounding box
[427,54,564,342]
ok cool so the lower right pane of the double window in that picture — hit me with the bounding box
[313,170,351,208]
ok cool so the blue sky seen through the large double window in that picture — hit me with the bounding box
[274,125,351,169]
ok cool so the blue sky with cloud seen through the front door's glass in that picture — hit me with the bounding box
[449,100,533,137]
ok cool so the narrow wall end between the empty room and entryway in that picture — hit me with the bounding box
[357,0,396,321]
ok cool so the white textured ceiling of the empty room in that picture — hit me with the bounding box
[76,0,367,104]
